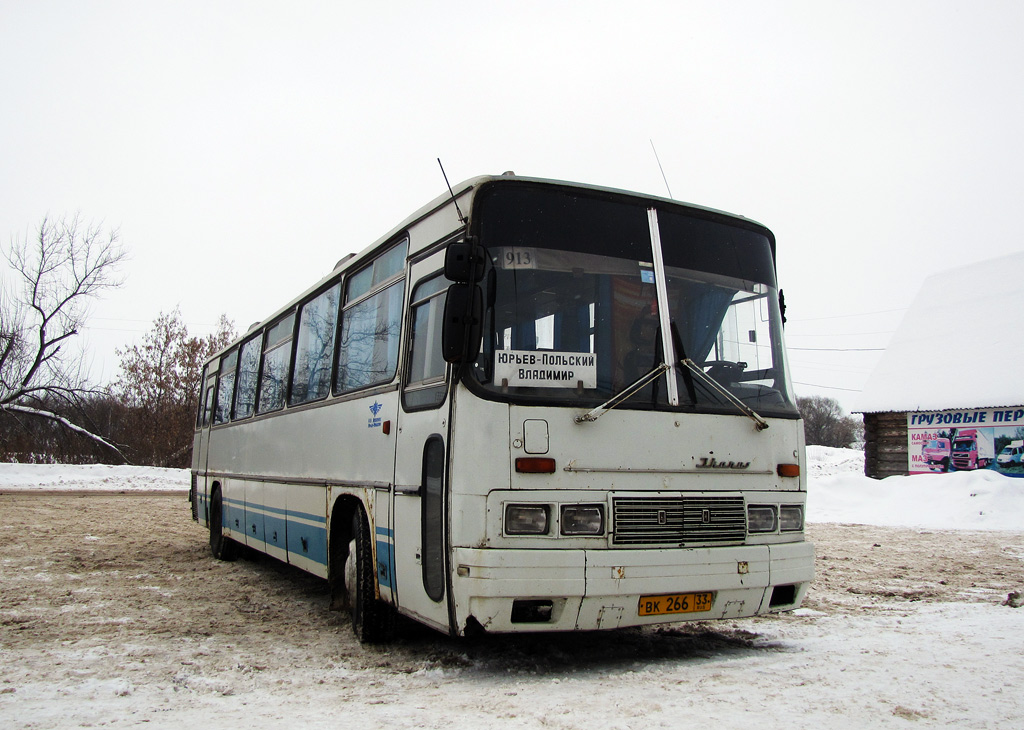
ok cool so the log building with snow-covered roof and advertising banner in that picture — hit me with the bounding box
[853,249,1024,478]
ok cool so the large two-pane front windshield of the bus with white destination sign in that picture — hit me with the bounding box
[471,183,797,418]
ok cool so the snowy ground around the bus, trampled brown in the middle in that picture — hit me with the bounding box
[0,447,1024,730]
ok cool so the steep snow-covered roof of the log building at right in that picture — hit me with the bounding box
[853,248,1024,414]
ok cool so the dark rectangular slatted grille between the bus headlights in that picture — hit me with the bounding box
[611,497,746,546]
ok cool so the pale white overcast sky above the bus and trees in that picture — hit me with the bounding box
[0,0,1024,410]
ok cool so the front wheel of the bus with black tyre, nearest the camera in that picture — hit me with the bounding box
[345,510,395,644]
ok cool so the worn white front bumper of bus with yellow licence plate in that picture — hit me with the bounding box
[453,542,814,634]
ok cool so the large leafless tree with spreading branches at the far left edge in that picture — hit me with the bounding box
[0,215,127,458]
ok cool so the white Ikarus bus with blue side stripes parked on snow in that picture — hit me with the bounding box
[191,174,814,642]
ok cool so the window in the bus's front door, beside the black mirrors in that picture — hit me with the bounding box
[403,274,449,409]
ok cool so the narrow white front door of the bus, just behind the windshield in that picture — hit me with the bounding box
[393,264,451,633]
